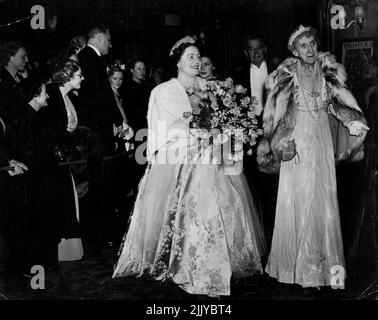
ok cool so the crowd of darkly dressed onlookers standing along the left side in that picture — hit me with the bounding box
[0,26,176,276]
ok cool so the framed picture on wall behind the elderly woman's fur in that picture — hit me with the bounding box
[342,38,374,87]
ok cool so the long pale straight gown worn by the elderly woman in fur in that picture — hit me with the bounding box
[265,64,345,288]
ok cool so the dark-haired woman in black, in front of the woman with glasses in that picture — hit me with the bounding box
[12,78,59,274]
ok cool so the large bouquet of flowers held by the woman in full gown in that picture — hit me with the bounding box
[183,78,263,161]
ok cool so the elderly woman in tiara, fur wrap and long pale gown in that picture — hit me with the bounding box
[257,26,368,288]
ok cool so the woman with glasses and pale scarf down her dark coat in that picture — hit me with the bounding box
[47,59,84,261]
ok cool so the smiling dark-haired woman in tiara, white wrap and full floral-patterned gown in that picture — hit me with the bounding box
[113,37,265,296]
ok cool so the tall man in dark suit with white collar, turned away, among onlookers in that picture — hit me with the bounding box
[77,26,114,254]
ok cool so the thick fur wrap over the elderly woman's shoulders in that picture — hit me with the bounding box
[257,52,366,173]
